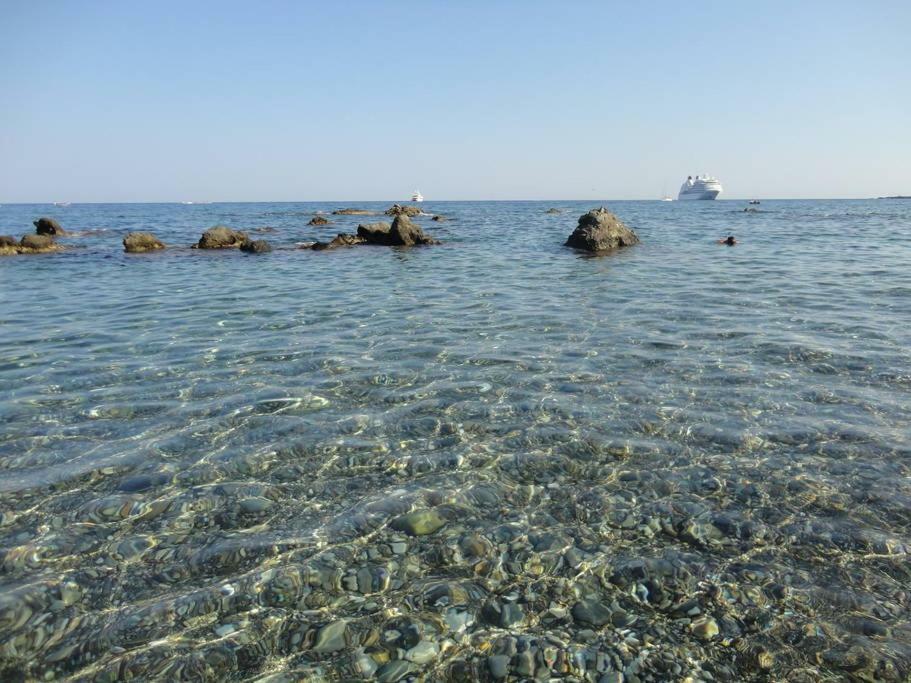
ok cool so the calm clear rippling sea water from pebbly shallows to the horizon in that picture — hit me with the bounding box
[0,200,911,683]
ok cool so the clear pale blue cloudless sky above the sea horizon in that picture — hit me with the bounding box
[0,0,911,203]
